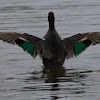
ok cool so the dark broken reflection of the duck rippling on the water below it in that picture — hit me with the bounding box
[22,67,93,100]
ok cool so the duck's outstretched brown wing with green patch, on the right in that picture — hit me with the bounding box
[63,32,100,58]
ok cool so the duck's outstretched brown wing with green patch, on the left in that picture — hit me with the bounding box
[0,32,42,57]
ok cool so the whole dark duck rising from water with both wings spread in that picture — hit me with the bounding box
[0,12,100,67]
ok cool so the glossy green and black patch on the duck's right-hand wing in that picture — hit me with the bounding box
[74,39,92,56]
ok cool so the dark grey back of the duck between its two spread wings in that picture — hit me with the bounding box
[42,30,65,67]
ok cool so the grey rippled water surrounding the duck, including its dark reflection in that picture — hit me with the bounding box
[0,0,100,100]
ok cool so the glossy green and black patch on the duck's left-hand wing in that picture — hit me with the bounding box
[15,38,34,56]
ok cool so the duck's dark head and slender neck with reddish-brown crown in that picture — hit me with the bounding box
[48,12,55,29]
